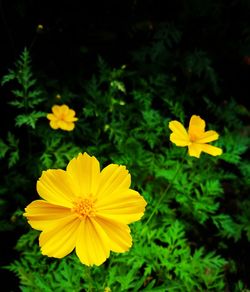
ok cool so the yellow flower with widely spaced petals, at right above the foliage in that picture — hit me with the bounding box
[169,115,222,158]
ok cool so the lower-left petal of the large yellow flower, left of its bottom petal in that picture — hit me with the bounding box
[39,216,81,258]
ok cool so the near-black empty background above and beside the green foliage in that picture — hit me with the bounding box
[0,0,250,291]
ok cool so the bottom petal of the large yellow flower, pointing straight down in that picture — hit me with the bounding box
[76,218,110,266]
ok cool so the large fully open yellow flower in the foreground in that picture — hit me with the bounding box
[24,153,147,266]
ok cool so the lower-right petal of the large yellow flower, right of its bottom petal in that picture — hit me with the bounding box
[95,217,132,252]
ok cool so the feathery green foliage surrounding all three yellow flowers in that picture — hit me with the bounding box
[0,24,250,292]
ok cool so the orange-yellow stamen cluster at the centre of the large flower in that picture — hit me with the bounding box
[71,198,95,219]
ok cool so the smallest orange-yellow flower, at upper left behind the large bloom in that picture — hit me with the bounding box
[47,104,78,131]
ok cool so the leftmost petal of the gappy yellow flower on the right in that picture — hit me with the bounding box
[169,121,189,146]
